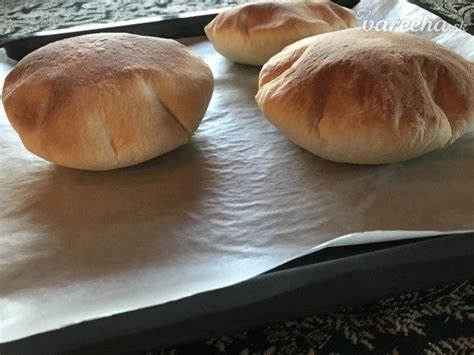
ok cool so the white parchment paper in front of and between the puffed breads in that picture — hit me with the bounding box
[0,2,474,342]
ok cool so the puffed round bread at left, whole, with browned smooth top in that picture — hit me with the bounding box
[3,33,214,170]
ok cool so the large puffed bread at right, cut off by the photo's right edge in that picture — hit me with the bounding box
[256,28,474,164]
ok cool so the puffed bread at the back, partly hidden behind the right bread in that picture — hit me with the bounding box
[204,1,357,65]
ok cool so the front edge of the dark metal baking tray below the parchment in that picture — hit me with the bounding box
[0,233,474,355]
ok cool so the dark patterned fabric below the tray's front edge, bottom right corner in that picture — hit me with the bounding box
[143,280,474,355]
